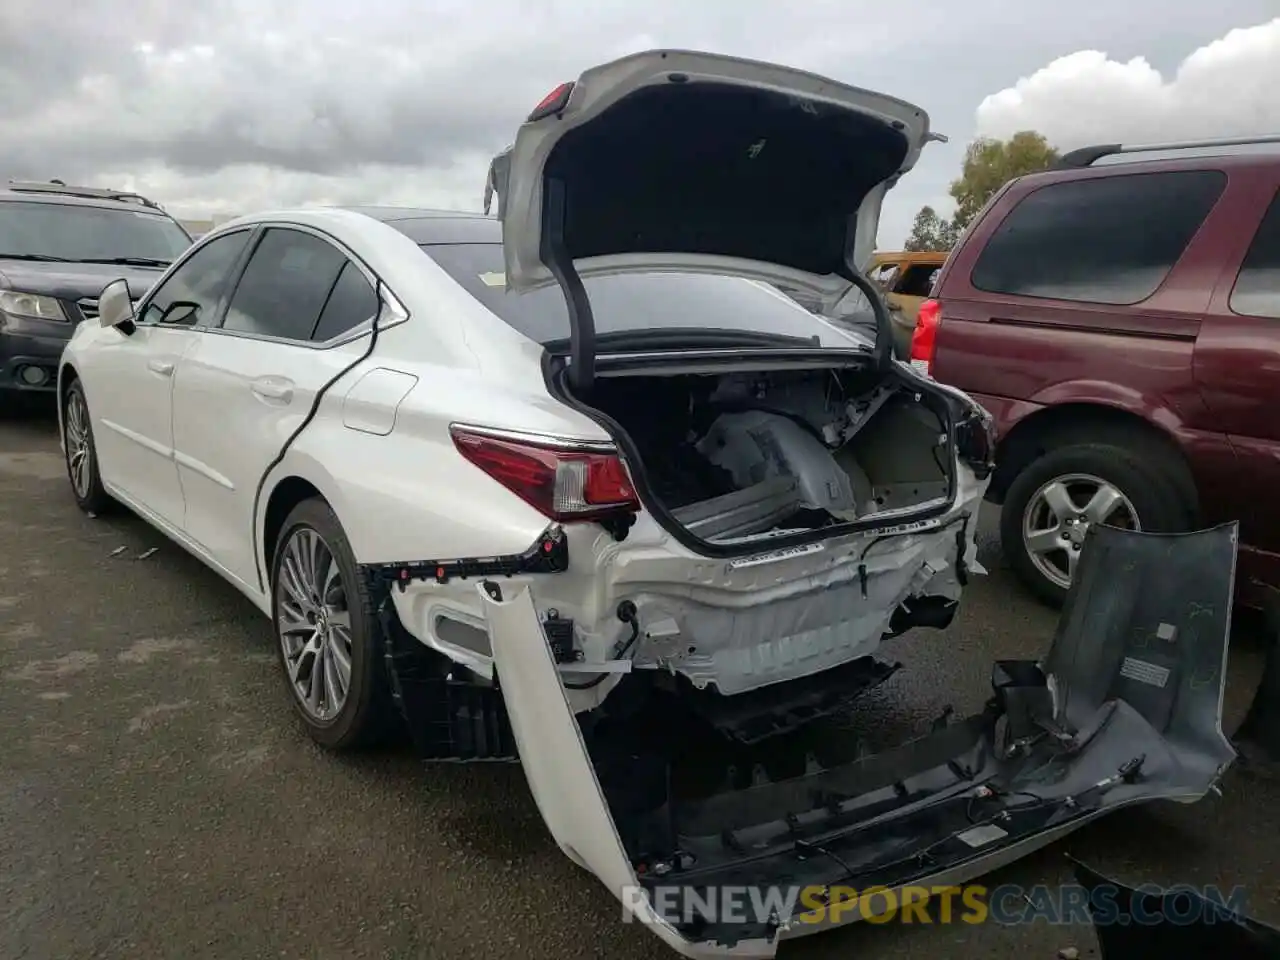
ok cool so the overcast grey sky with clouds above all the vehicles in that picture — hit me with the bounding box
[0,0,1280,246]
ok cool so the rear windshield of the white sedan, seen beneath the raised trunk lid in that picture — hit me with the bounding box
[422,243,874,349]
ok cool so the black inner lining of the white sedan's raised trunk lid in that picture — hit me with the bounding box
[547,83,908,275]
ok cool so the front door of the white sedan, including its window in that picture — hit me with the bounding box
[86,230,250,529]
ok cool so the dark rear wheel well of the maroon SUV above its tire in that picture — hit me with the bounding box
[987,403,1199,513]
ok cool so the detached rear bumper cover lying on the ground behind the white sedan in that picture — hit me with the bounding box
[481,525,1236,957]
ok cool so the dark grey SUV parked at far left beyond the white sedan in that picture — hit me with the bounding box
[0,183,191,403]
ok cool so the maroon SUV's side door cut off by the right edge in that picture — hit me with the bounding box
[1196,168,1280,553]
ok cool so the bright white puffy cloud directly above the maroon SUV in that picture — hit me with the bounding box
[977,18,1280,150]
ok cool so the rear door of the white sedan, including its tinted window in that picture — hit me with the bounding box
[173,227,379,590]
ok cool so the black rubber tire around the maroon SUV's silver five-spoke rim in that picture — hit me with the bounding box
[1000,442,1194,607]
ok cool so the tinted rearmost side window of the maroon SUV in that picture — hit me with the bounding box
[970,170,1226,306]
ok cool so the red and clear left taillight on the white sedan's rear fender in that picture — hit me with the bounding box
[449,428,640,524]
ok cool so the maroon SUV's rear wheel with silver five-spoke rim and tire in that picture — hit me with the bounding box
[1000,443,1190,607]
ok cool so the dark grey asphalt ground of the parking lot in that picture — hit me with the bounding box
[0,399,1280,960]
